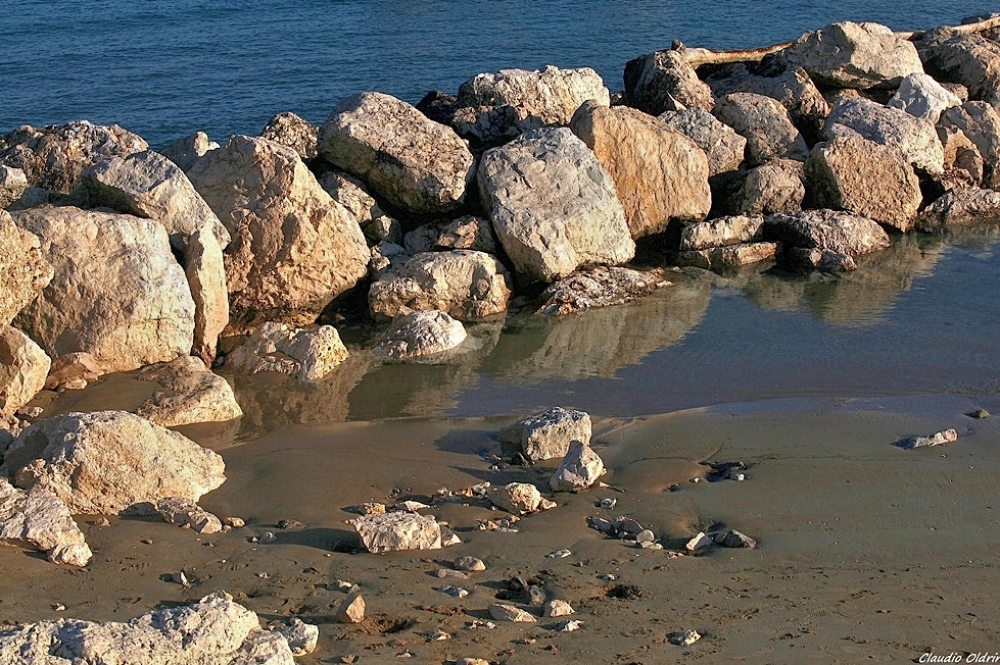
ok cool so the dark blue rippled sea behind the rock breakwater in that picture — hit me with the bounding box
[0,0,996,147]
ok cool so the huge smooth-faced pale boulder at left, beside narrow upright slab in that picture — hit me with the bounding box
[14,207,195,372]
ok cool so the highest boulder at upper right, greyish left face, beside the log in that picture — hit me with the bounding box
[782,21,924,90]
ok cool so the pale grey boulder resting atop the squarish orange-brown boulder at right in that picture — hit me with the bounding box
[823,98,944,177]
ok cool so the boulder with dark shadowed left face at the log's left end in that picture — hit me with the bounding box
[624,51,715,115]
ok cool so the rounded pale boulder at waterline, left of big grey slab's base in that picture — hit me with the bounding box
[368,250,510,321]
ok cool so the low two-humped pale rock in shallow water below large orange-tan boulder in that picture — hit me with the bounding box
[226,322,348,381]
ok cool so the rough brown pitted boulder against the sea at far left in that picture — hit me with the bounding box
[0,120,149,194]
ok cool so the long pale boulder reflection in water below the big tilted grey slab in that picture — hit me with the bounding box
[483,273,711,384]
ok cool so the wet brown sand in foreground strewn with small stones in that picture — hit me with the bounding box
[0,395,1000,665]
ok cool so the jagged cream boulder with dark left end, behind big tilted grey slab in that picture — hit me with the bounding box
[452,66,611,143]
